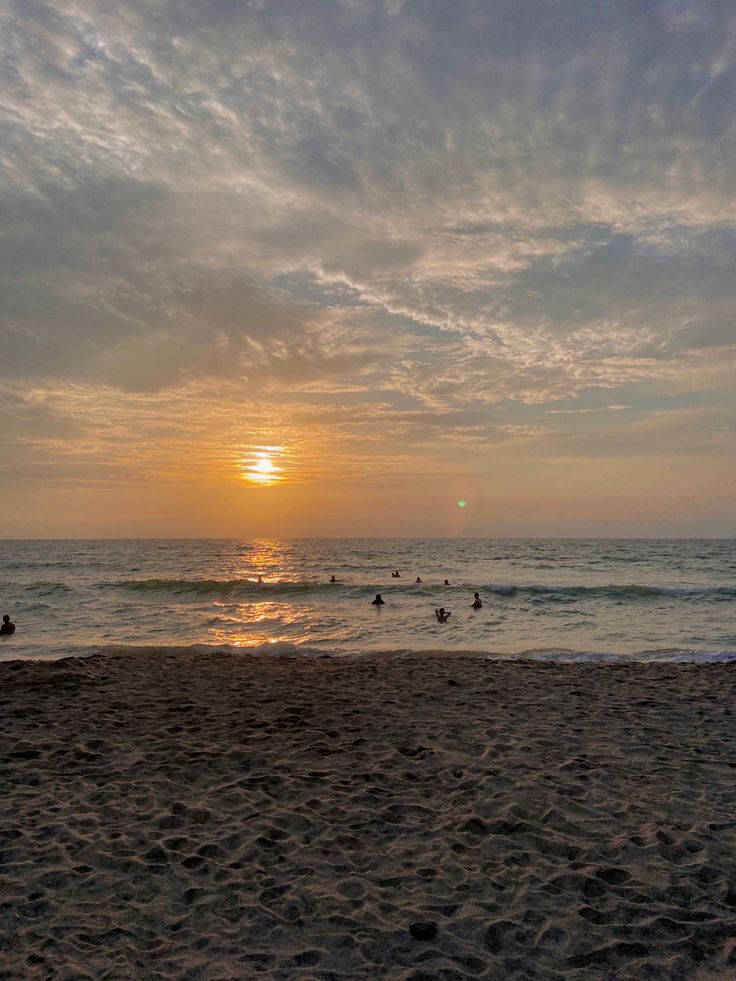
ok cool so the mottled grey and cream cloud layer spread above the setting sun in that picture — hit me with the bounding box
[0,0,736,512]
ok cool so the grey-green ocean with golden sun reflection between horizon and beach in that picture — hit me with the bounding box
[0,539,736,662]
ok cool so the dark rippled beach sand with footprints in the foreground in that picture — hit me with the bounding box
[0,653,736,981]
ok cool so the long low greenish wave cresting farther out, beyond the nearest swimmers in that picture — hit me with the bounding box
[112,579,736,602]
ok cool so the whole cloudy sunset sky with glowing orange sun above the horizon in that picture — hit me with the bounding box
[0,0,736,538]
